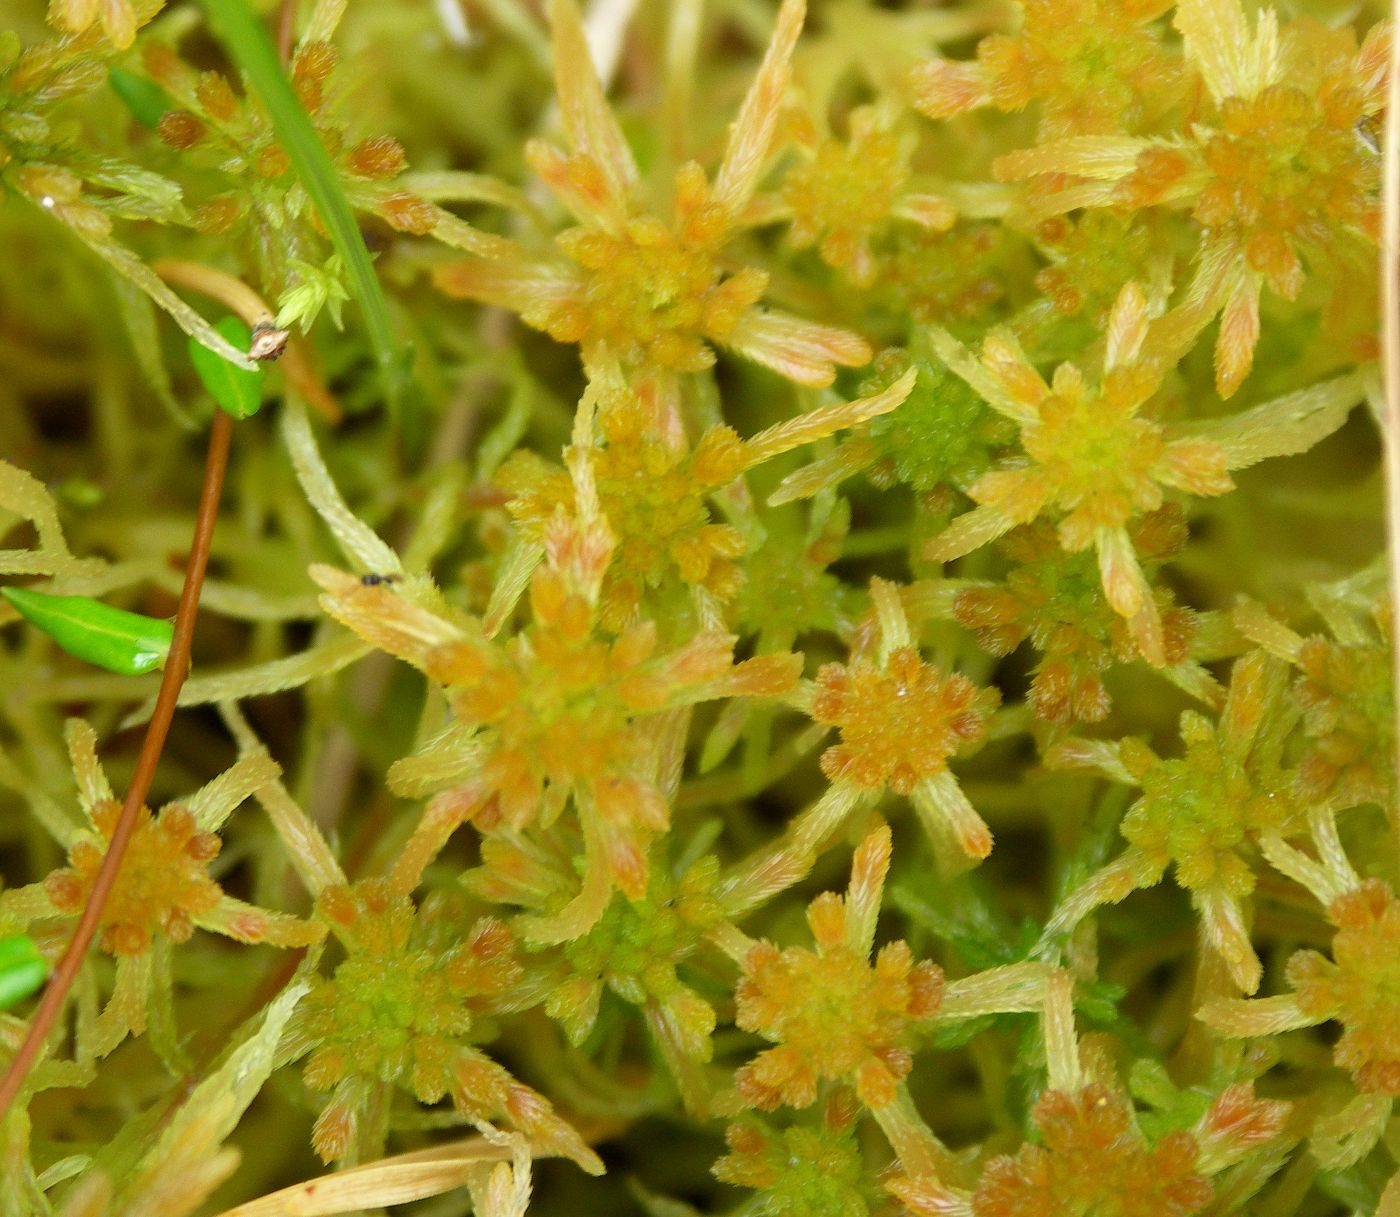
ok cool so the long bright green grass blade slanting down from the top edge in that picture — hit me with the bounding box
[200,0,413,430]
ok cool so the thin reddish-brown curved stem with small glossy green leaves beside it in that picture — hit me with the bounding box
[0,410,234,1119]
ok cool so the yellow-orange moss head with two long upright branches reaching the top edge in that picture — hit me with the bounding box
[435,17,871,387]
